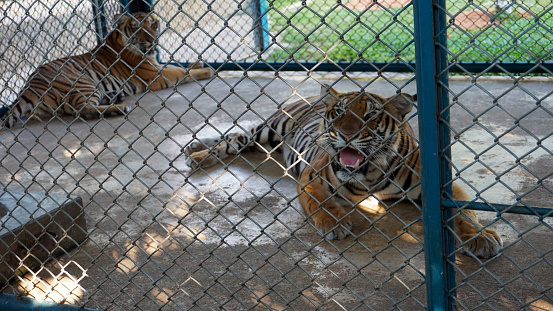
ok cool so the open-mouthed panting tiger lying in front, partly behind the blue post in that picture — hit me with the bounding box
[186,86,503,258]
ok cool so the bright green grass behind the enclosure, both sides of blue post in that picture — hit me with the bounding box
[268,0,553,66]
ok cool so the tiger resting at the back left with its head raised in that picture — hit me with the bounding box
[0,13,213,128]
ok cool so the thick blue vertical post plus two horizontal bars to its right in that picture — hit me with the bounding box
[413,0,553,310]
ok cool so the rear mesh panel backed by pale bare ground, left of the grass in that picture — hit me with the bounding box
[155,0,259,62]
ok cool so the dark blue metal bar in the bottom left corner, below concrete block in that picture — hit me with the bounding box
[0,294,99,311]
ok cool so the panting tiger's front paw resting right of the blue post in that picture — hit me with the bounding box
[461,229,503,258]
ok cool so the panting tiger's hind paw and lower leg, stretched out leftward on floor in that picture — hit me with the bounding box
[184,134,246,168]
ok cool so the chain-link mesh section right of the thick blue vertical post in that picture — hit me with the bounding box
[438,1,553,310]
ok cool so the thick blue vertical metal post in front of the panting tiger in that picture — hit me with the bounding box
[413,0,451,310]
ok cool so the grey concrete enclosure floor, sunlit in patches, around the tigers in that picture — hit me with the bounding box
[0,73,553,310]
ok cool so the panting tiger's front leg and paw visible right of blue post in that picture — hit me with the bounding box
[453,183,503,258]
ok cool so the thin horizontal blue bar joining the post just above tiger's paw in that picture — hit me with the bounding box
[442,200,553,217]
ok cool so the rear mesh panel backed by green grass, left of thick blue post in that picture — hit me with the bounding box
[268,1,414,62]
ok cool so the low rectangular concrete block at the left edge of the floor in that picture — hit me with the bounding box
[0,190,87,282]
